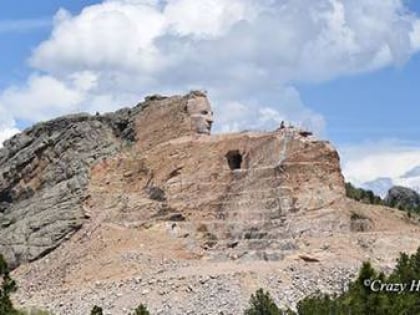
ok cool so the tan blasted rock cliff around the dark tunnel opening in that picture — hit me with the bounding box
[90,96,351,260]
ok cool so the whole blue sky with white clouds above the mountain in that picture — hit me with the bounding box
[0,0,420,188]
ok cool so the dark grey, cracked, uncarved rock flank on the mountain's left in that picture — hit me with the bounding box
[0,108,139,267]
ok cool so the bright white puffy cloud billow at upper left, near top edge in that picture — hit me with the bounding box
[31,2,165,74]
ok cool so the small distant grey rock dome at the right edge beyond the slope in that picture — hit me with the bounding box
[384,186,420,210]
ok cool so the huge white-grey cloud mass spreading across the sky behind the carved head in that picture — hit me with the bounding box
[0,0,420,136]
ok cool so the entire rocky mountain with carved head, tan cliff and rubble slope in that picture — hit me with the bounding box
[0,91,420,315]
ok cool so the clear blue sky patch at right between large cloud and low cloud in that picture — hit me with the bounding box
[300,55,420,144]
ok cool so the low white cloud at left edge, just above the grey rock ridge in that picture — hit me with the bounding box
[0,71,141,125]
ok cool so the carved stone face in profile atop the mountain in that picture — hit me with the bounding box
[187,96,213,134]
